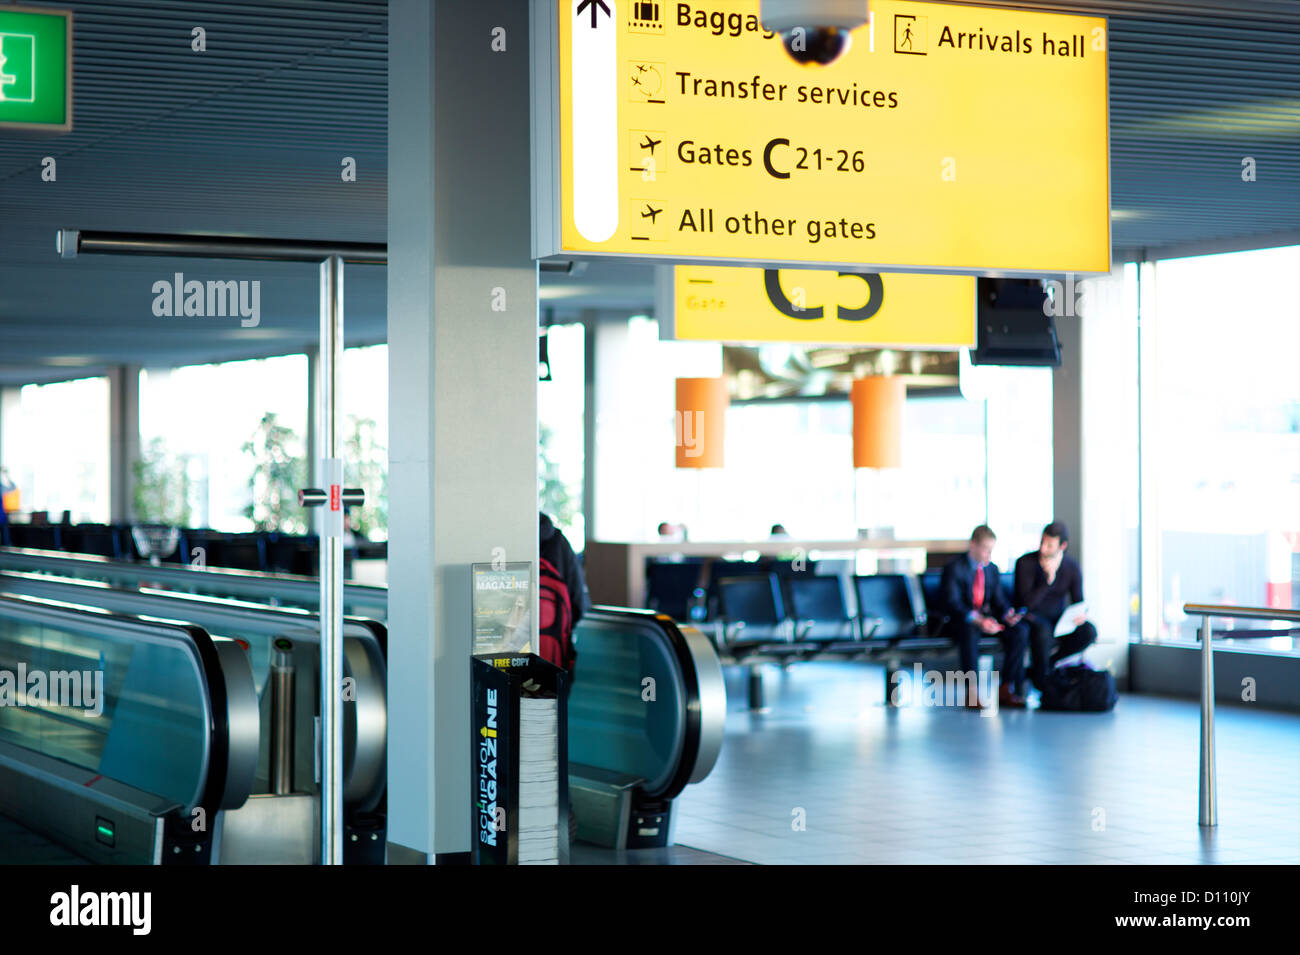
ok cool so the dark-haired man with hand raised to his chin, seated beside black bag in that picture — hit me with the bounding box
[1013,521,1097,690]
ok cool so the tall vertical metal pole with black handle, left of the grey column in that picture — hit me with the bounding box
[316,255,343,865]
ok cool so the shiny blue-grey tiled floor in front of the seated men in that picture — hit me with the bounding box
[675,663,1300,864]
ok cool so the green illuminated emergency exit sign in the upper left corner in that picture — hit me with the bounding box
[0,6,73,131]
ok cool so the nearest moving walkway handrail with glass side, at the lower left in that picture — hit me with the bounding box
[0,595,259,864]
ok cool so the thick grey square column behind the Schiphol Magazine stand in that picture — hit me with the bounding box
[389,0,538,861]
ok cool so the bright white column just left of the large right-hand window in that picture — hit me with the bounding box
[1052,266,1138,677]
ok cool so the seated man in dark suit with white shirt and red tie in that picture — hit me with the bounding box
[939,524,1028,707]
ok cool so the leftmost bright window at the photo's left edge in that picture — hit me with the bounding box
[0,378,109,524]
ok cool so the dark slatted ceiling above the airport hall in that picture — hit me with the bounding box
[0,0,1300,383]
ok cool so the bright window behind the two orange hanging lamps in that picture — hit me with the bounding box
[595,318,1052,553]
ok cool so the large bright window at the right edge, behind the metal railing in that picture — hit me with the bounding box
[1144,246,1300,651]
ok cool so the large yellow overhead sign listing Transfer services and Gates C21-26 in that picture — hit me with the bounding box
[534,0,1110,274]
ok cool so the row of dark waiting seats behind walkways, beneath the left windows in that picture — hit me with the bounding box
[0,522,377,576]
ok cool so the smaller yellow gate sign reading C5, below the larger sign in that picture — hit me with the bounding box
[666,265,975,348]
